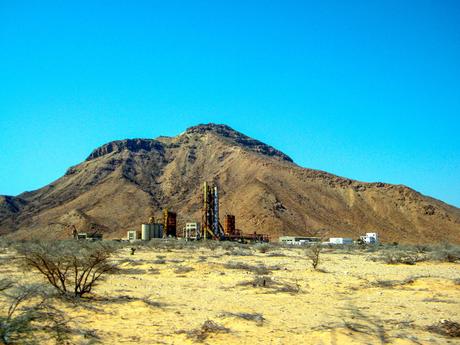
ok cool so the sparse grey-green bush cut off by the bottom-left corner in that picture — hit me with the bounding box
[0,280,70,345]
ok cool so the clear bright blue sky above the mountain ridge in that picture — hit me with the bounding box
[0,0,460,206]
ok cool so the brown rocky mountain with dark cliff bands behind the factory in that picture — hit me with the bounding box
[0,124,460,242]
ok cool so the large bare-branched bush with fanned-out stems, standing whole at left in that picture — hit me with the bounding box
[18,241,116,297]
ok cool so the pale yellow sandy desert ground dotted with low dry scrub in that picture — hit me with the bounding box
[0,242,460,344]
